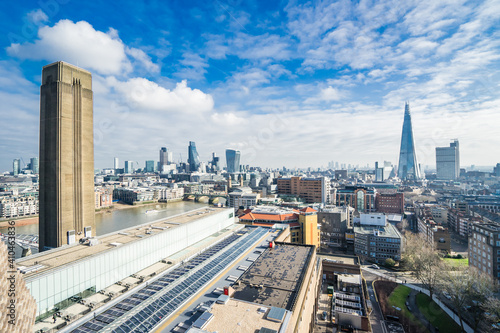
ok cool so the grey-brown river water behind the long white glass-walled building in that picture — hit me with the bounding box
[0,201,207,249]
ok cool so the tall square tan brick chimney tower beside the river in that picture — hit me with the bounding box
[39,61,95,251]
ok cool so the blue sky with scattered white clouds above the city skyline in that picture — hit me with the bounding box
[0,0,500,170]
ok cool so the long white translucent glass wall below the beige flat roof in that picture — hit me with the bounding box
[17,209,234,316]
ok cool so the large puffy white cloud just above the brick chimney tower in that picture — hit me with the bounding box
[7,20,158,75]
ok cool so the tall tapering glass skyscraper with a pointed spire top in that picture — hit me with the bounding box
[398,102,422,180]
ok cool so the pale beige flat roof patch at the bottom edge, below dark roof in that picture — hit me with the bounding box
[203,299,282,333]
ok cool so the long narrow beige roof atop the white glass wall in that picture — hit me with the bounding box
[16,207,225,278]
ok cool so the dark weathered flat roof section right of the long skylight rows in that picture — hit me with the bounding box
[233,243,314,311]
